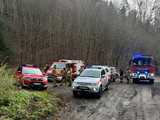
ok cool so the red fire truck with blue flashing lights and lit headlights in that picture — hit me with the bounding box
[130,53,156,84]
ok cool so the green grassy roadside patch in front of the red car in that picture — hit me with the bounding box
[0,65,58,120]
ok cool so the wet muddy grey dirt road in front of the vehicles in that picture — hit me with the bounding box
[50,78,160,120]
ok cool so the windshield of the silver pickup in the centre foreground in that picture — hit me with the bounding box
[80,70,100,78]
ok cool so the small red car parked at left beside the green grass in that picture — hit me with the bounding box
[16,64,48,89]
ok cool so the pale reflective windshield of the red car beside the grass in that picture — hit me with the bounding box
[22,67,42,75]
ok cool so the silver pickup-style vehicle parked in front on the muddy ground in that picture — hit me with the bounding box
[72,68,109,97]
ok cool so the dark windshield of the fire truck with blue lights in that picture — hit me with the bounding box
[132,58,152,66]
